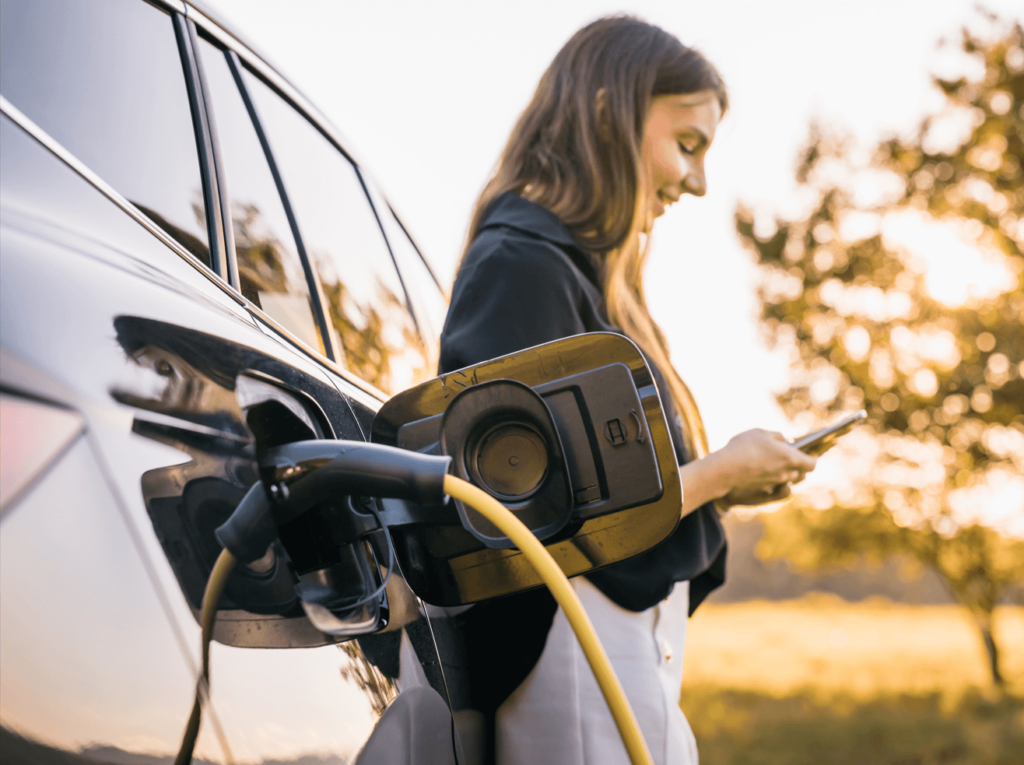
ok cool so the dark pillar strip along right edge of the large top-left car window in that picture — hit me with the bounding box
[171,13,226,279]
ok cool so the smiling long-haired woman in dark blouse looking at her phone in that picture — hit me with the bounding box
[440,16,814,765]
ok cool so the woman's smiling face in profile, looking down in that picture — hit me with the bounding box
[641,90,722,219]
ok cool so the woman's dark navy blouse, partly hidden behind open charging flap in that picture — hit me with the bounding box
[438,194,726,707]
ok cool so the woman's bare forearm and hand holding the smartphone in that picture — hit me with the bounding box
[679,428,817,515]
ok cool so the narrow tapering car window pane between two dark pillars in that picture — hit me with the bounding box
[192,40,324,352]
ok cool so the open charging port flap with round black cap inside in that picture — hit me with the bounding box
[373,333,682,605]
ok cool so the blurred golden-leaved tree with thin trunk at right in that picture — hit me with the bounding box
[736,16,1024,686]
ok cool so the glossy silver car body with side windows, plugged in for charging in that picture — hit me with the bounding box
[0,0,481,765]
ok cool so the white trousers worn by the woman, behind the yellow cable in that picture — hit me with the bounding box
[495,577,697,765]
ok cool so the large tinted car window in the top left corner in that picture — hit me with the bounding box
[0,0,210,265]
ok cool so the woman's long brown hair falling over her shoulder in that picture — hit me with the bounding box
[467,16,728,459]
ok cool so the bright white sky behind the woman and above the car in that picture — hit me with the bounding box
[203,0,1024,459]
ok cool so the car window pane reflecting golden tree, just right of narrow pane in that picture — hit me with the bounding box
[246,72,436,393]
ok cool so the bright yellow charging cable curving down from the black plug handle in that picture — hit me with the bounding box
[444,475,652,765]
